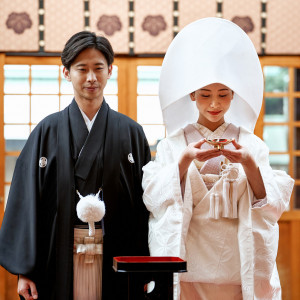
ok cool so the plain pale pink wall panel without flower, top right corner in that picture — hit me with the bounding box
[266,0,300,55]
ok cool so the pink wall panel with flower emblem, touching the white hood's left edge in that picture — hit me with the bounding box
[134,0,173,53]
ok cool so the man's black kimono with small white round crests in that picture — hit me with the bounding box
[0,100,150,300]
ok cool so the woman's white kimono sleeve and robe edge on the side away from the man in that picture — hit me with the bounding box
[241,130,294,300]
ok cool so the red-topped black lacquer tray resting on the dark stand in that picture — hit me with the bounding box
[113,256,187,273]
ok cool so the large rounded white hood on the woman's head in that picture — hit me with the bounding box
[159,18,263,134]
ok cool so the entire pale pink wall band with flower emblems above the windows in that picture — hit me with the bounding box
[0,0,300,55]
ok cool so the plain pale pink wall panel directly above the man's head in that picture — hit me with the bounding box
[43,0,84,52]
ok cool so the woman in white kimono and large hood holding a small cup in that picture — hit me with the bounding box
[143,18,294,300]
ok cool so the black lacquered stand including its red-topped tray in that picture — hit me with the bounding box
[113,256,187,300]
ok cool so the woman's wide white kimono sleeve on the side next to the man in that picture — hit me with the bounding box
[142,136,186,256]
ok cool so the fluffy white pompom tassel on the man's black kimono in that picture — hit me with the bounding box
[76,189,105,236]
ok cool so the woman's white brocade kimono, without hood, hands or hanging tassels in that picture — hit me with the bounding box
[143,128,294,300]
